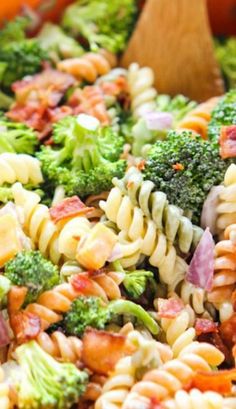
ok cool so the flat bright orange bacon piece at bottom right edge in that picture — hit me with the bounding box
[190,369,236,394]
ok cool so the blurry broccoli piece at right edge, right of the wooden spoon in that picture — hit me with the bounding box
[215,37,236,89]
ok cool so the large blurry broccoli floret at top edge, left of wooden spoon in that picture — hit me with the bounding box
[62,0,137,53]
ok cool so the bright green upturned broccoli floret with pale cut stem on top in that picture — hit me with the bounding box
[37,114,126,197]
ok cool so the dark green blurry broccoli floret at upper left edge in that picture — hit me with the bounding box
[0,39,47,90]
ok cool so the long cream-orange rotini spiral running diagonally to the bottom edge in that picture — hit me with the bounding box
[122,341,224,409]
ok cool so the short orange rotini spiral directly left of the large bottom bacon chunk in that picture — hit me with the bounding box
[37,331,83,363]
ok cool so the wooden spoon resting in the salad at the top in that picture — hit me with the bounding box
[121,0,224,101]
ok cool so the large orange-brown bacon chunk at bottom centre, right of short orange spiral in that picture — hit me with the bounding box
[82,328,130,375]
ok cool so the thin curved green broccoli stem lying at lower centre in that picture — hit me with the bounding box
[108,300,159,335]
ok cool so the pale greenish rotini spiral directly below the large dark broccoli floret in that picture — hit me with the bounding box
[112,167,202,253]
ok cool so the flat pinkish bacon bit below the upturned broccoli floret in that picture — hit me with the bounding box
[49,196,93,223]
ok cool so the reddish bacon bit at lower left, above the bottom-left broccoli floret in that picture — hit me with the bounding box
[10,311,41,344]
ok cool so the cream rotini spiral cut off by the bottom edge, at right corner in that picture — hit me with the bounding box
[163,389,236,409]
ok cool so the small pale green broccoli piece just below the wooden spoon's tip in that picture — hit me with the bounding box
[156,94,197,126]
